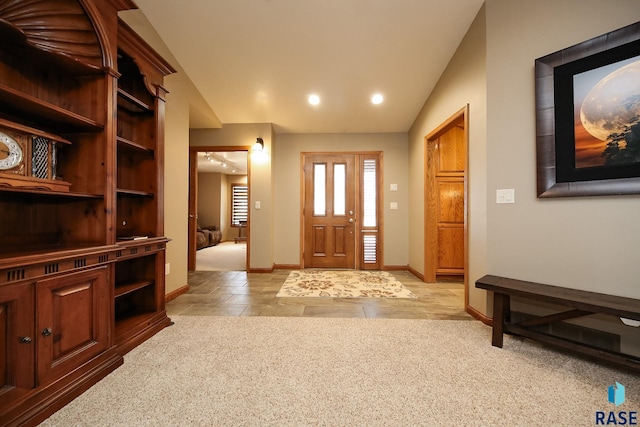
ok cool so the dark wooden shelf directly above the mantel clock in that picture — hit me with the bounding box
[0,83,104,132]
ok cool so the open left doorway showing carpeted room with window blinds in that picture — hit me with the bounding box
[188,146,250,271]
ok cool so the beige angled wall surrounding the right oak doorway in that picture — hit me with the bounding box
[409,7,487,314]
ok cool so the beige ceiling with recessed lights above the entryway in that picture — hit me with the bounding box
[135,0,484,133]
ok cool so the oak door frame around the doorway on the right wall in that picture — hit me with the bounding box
[424,104,469,308]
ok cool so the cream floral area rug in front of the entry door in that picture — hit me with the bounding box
[276,270,416,298]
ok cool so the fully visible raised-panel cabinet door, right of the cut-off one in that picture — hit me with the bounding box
[36,267,111,384]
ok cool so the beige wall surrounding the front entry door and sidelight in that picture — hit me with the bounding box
[274,133,409,266]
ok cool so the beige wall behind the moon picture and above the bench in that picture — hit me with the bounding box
[484,0,640,298]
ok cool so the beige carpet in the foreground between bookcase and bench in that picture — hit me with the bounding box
[43,316,640,427]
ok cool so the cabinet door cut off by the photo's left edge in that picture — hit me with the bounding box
[0,285,35,406]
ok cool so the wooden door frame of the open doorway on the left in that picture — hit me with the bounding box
[187,145,251,271]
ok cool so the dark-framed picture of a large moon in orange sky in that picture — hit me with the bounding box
[535,22,640,198]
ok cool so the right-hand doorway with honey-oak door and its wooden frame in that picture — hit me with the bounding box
[424,105,469,306]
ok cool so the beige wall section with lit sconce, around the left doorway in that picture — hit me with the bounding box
[189,123,274,270]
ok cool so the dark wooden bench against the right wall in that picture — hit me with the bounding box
[476,275,640,371]
